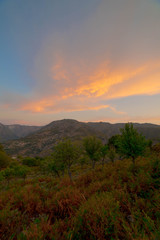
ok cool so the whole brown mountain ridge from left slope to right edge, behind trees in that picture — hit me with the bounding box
[3,119,160,156]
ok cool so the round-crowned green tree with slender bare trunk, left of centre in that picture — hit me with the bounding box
[53,139,79,182]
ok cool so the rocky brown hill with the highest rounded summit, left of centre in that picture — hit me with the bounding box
[3,119,105,156]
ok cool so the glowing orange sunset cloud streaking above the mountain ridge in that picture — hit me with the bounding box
[21,61,160,114]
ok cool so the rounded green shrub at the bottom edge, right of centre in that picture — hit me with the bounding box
[72,192,122,240]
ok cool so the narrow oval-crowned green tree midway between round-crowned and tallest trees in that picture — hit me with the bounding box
[83,136,102,169]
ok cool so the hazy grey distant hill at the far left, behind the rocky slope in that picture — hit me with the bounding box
[0,123,40,142]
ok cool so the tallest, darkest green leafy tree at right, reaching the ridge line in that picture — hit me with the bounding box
[118,123,147,163]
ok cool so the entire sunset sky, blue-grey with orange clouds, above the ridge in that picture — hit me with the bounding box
[0,0,160,125]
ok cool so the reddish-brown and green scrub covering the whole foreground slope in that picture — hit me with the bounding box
[0,157,160,240]
